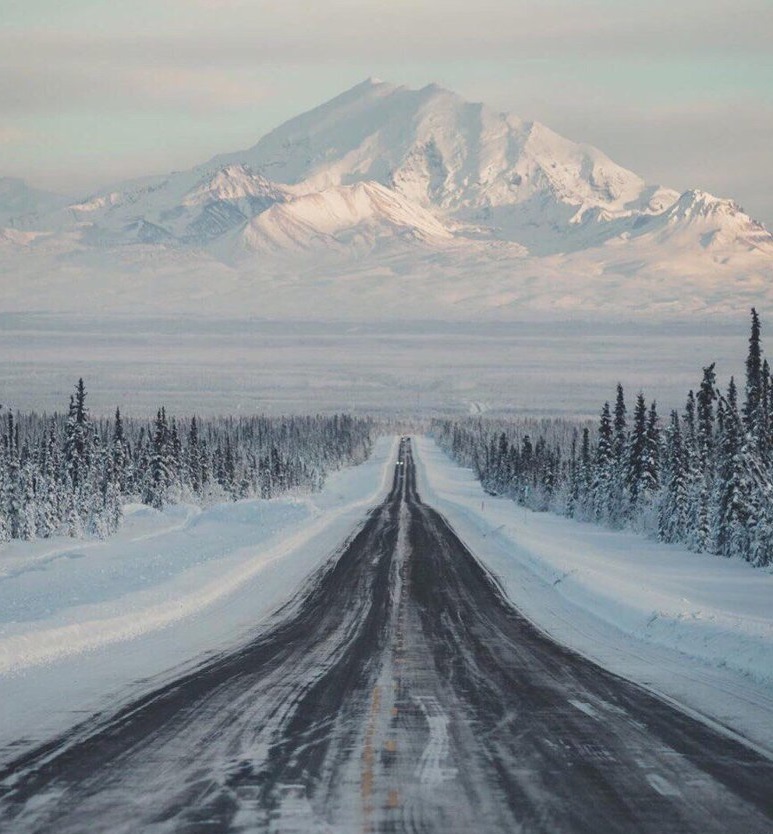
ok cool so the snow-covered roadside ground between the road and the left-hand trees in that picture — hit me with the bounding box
[0,438,396,751]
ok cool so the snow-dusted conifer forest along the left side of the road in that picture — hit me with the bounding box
[0,379,373,541]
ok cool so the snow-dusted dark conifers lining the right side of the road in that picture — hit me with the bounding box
[432,309,773,566]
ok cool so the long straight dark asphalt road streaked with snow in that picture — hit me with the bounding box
[0,441,773,834]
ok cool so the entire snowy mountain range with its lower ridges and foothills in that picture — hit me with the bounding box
[0,79,773,317]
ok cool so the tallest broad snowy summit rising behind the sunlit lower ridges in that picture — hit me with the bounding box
[212,79,664,219]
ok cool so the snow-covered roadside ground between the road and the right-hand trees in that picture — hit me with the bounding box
[415,438,773,752]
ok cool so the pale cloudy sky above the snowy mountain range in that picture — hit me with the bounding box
[0,0,773,228]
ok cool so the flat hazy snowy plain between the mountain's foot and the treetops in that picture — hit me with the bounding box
[0,310,748,419]
